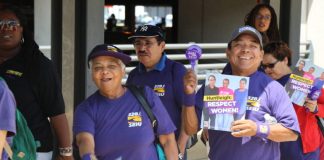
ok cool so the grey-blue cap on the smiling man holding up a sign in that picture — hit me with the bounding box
[228,26,263,48]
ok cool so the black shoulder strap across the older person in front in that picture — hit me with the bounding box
[126,85,157,134]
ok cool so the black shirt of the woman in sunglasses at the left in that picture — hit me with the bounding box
[0,44,65,152]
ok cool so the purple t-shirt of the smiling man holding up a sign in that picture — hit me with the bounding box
[196,71,300,160]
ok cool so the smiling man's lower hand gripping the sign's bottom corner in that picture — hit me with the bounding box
[231,120,257,137]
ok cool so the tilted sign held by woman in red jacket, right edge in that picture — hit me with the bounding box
[285,59,324,106]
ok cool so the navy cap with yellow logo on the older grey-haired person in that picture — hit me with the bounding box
[88,44,131,64]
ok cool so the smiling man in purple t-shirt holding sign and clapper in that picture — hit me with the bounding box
[184,26,300,160]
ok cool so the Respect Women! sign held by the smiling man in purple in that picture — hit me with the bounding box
[201,73,249,131]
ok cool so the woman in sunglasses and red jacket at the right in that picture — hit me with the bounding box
[261,42,324,160]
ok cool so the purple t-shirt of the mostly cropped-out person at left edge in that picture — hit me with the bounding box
[0,79,16,159]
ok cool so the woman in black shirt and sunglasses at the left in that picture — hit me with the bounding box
[0,4,73,160]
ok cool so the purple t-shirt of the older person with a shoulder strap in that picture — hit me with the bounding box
[73,87,176,160]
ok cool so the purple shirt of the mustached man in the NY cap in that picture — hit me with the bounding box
[127,54,186,138]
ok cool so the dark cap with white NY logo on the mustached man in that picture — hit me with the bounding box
[128,25,164,39]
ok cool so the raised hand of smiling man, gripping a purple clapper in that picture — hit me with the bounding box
[183,69,197,94]
